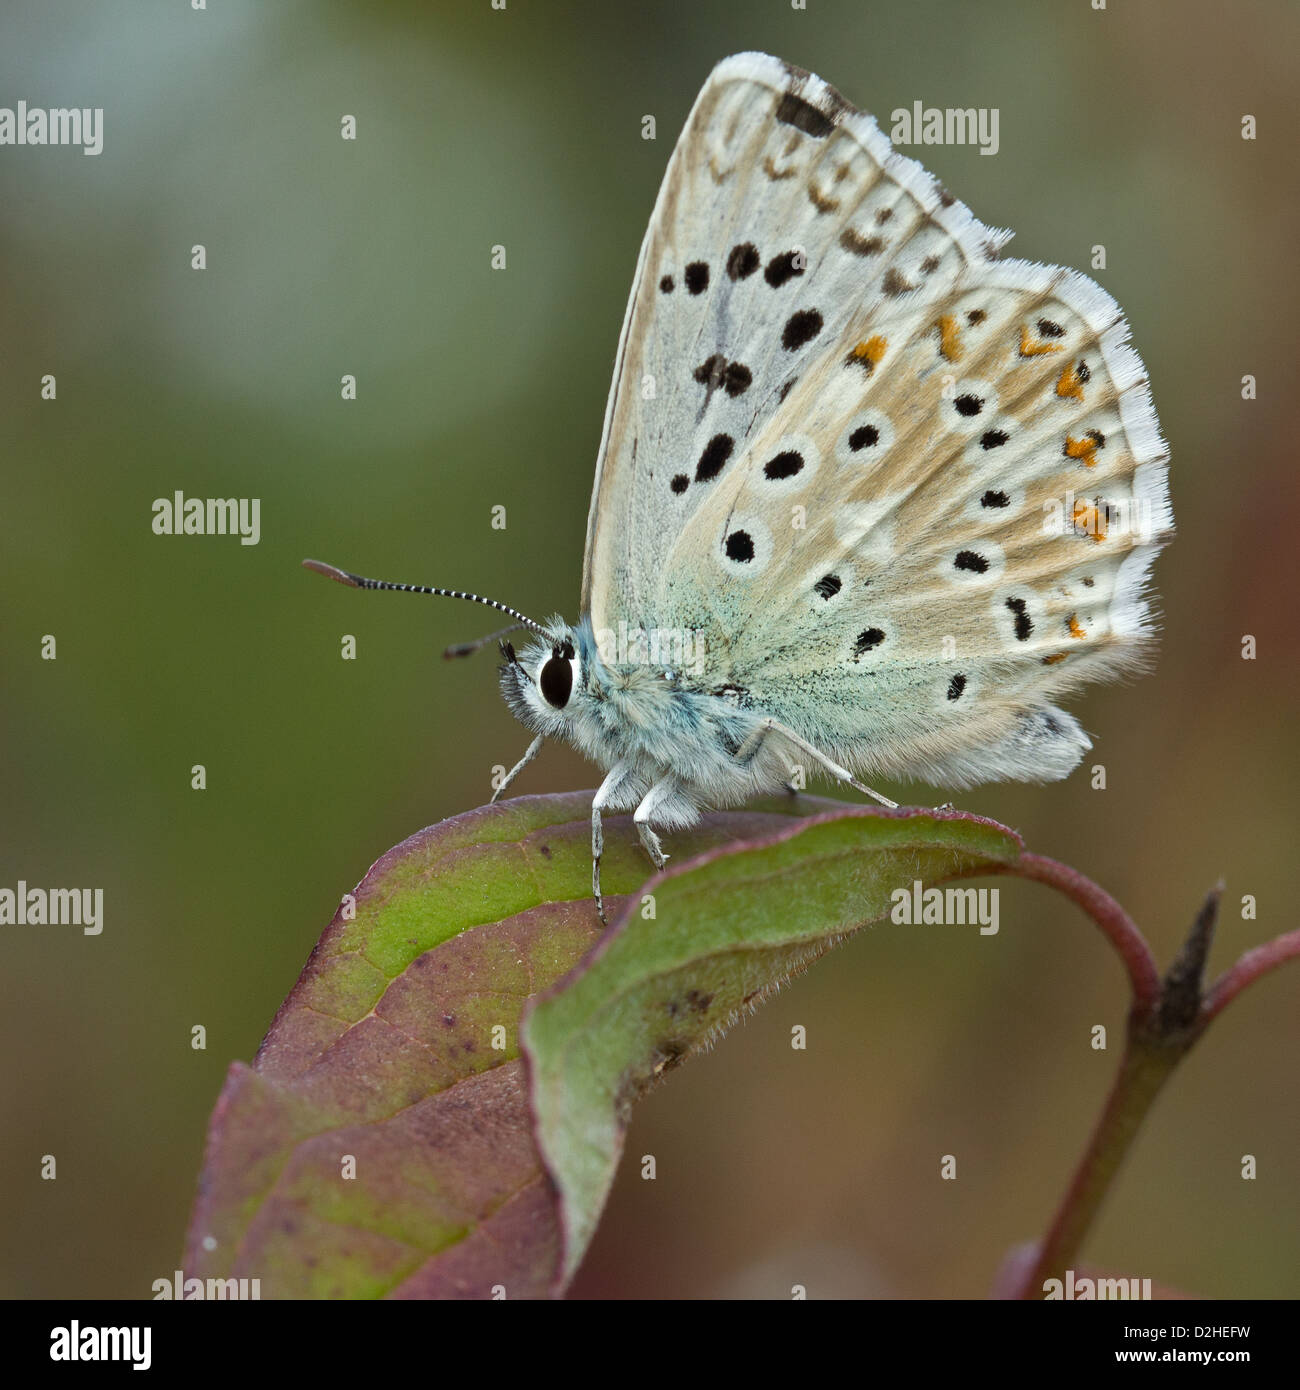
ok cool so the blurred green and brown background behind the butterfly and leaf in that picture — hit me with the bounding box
[0,0,1300,1298]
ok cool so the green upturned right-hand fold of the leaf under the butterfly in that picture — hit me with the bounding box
[524,803,1022,1284]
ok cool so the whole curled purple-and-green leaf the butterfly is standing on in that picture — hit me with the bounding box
[185,792,1019,1298]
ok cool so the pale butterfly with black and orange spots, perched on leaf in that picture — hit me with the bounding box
[304,53,1173,920]
